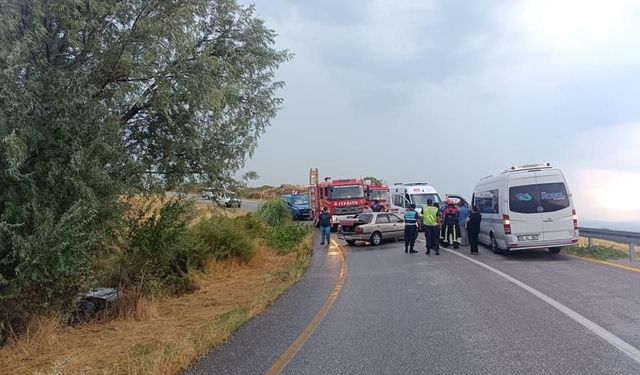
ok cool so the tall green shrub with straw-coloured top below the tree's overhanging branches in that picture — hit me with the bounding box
[113,198,197,294]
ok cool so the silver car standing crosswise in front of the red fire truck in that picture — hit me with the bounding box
[338,212,404,246]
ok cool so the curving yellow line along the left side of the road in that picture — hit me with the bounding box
[265,240,347,375]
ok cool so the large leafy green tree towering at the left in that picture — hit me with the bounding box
[0,0,290,340]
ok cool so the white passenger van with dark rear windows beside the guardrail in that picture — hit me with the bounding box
[471,163,579,254]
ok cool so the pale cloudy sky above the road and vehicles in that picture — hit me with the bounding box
[239,0,640,231]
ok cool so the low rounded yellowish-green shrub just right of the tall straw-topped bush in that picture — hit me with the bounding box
[190,216,256,265]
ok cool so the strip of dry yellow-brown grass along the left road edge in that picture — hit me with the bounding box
[0,238,311,374]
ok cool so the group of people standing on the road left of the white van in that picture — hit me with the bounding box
[404,199,482,255]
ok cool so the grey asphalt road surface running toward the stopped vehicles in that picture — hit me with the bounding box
[186,232,640,374]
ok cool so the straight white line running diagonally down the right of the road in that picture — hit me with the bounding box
[420,241,640,364]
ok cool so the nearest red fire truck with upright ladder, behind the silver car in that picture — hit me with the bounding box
[309,168,368,231]
